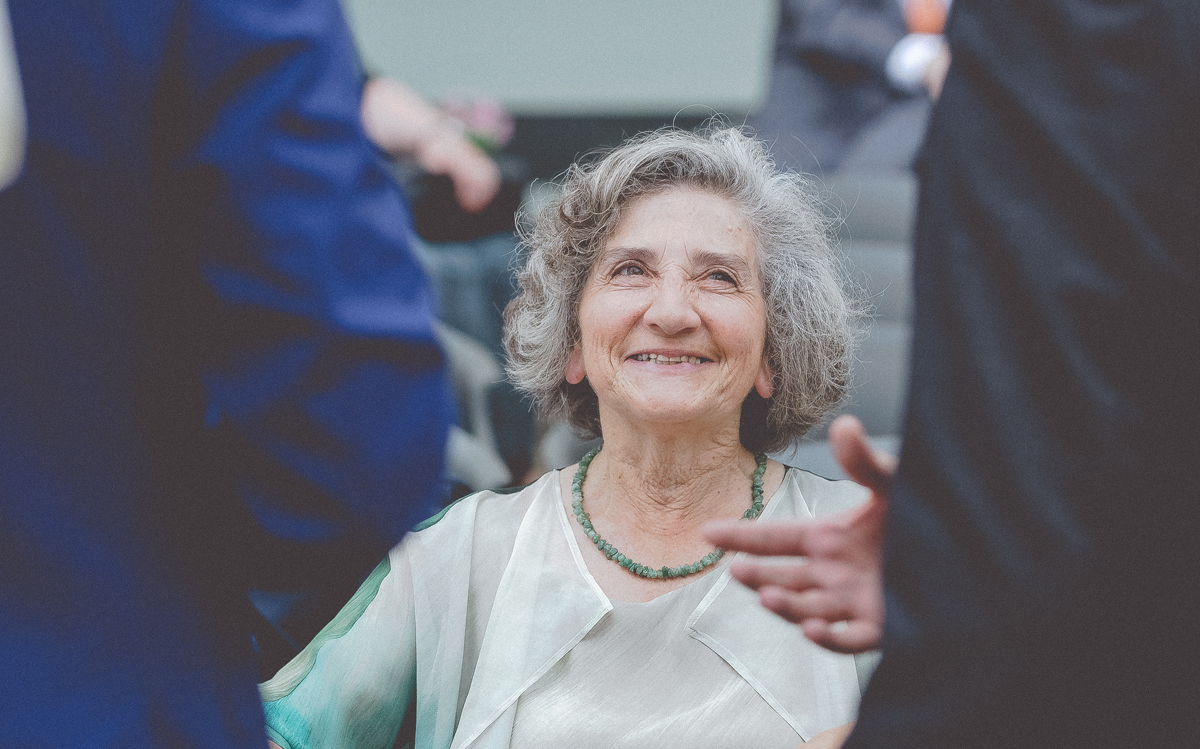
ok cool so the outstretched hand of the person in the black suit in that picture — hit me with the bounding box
[704,417,896,653]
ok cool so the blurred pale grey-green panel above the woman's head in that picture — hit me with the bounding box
[343,0,778,116]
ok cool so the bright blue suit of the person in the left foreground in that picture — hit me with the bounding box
[0,0,454,748]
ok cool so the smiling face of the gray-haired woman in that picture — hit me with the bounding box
[566,187,772,433]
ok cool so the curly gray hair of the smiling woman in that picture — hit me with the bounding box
[504,126,858,451]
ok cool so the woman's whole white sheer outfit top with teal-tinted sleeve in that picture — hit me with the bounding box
[260,468,878,749]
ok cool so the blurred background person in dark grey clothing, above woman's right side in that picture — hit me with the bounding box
[748,0,949,175]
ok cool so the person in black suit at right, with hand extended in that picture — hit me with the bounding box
[709,0,1200,749]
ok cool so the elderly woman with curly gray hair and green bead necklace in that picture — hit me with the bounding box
[262,130,863,749]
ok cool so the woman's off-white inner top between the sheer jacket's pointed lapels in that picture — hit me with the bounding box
[512,573,803,749]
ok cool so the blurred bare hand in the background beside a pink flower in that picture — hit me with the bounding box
[362,78,500,214]
